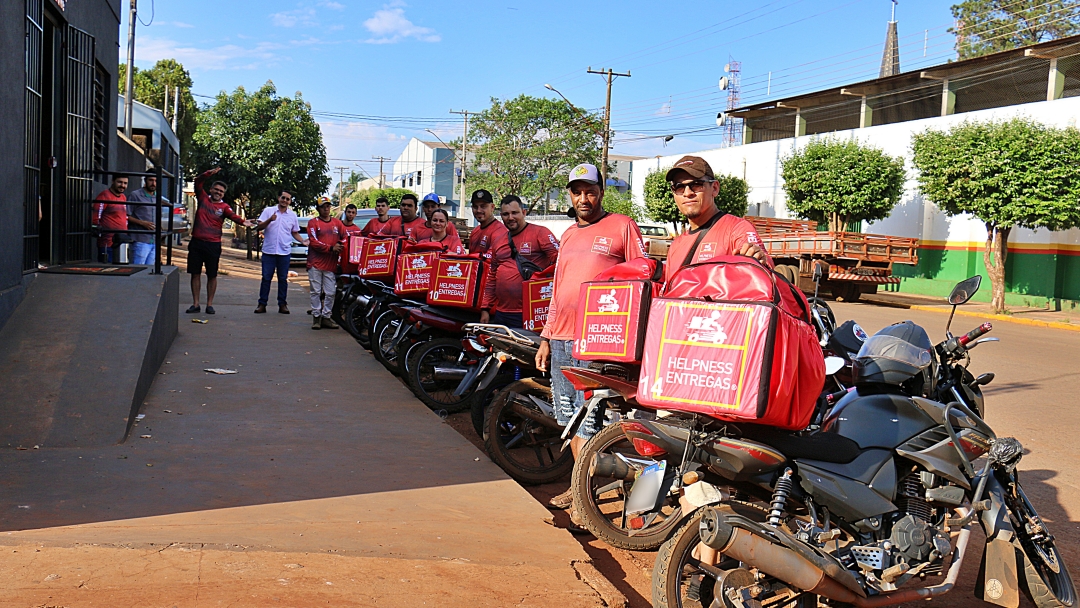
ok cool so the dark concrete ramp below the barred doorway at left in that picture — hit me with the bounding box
[0,268,180,448]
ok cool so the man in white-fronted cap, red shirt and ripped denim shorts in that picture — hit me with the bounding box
[537,164,645,509]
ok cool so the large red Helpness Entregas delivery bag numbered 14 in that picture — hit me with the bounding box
[637,256,825,430]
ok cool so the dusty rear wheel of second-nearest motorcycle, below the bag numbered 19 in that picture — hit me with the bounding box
[570,424,685,551]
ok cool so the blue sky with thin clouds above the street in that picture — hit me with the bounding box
[130,0,955,190]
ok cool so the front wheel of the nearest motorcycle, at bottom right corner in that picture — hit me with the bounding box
[1005,473,1077,608]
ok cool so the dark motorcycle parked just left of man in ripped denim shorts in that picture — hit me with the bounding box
[457,323,573,485]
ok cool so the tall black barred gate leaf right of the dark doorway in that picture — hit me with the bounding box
[62,26,97,262]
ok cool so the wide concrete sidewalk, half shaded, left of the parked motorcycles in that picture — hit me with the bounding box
[0,271,618,607]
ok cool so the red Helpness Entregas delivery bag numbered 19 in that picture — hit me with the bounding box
[573,258,663,363]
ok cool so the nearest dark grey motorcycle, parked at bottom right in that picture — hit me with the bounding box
[648,276,1077,608]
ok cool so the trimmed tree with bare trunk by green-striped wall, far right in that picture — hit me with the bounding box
[912,118,1080,312]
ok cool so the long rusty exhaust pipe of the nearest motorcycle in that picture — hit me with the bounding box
[699,508,971,608]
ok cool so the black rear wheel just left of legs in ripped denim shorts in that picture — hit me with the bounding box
[484,378,573,485]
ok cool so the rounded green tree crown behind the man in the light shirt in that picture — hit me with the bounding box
[194,81,330,217]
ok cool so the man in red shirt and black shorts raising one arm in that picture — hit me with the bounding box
[185,167,255,314]
